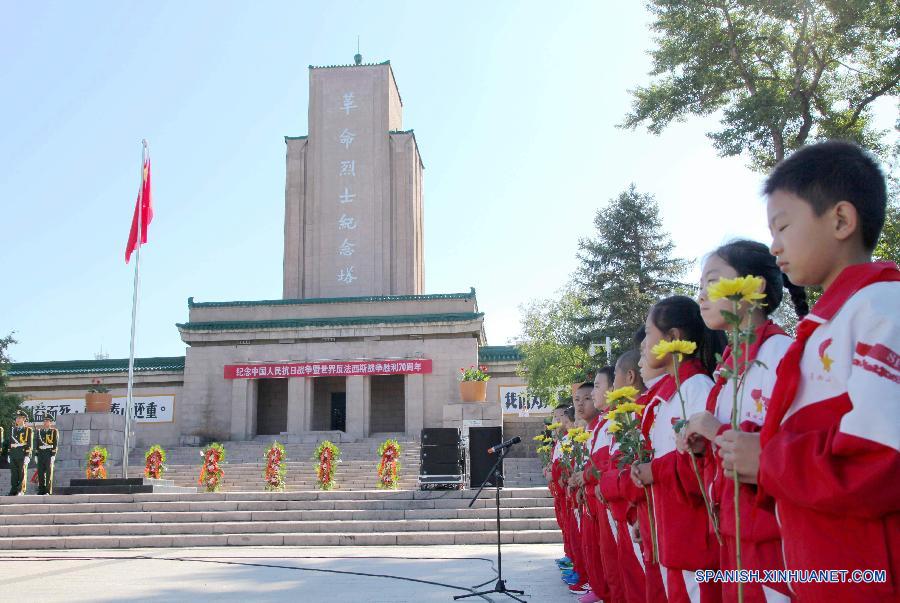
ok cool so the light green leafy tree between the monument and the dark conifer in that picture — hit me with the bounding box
[516,291,591,407]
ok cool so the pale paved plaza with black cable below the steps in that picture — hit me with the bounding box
[0,544,571,603]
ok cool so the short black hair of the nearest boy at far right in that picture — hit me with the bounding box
[763,140,887,251]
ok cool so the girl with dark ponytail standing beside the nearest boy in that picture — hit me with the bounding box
[678,240,807,603]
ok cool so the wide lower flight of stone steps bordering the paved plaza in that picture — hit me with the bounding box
[0,487,561,550]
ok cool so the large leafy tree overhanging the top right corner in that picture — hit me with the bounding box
[623,0,900,170]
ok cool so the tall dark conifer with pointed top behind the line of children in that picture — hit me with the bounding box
[575,184,689,351]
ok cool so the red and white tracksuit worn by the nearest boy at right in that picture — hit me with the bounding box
[758,262,900,603]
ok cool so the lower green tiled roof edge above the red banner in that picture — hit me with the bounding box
[175,312,484,331]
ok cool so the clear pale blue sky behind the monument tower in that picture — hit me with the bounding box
[0,1,895,361]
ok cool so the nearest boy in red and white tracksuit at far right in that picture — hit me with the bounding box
[717,141,900,603]
